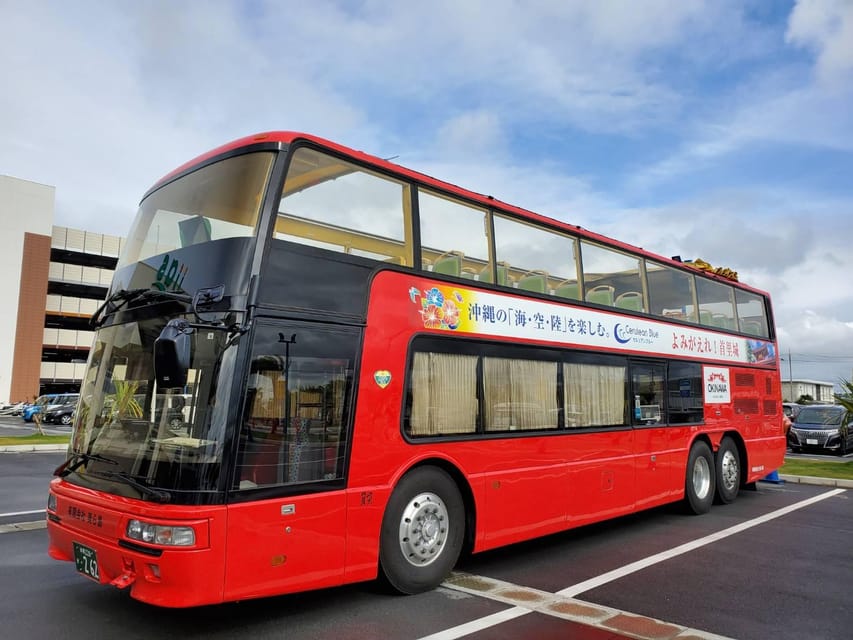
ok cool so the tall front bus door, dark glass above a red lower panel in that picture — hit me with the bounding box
[225,321,359,600]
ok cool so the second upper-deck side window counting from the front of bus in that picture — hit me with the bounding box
[418,190,491,279]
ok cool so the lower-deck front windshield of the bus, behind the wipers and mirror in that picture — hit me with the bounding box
[67,318,236,501]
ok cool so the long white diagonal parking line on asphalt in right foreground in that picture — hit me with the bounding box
[420,489,845,640]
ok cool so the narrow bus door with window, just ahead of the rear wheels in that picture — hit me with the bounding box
[630,361,674,508]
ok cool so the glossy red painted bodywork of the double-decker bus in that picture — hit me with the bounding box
[48,134,785,607]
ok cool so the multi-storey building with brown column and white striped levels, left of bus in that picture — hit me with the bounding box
[0,176,123,402]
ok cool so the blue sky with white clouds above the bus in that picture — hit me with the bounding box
[0,0,853,382]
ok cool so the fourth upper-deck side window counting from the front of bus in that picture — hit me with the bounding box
[581,241,646,311]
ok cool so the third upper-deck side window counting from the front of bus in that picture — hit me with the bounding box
[492,215,580,299]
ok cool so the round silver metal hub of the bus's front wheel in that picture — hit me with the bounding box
[400,493,450,567]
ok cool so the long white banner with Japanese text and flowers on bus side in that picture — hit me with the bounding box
[408,281,776,365]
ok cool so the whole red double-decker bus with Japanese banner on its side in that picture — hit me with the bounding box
[47,132,785,607]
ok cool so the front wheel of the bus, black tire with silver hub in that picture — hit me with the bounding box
[379,467,465,594]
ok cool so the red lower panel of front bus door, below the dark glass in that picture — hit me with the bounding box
[225,491,347,600]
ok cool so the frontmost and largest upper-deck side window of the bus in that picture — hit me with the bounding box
[275,148,412,265]
